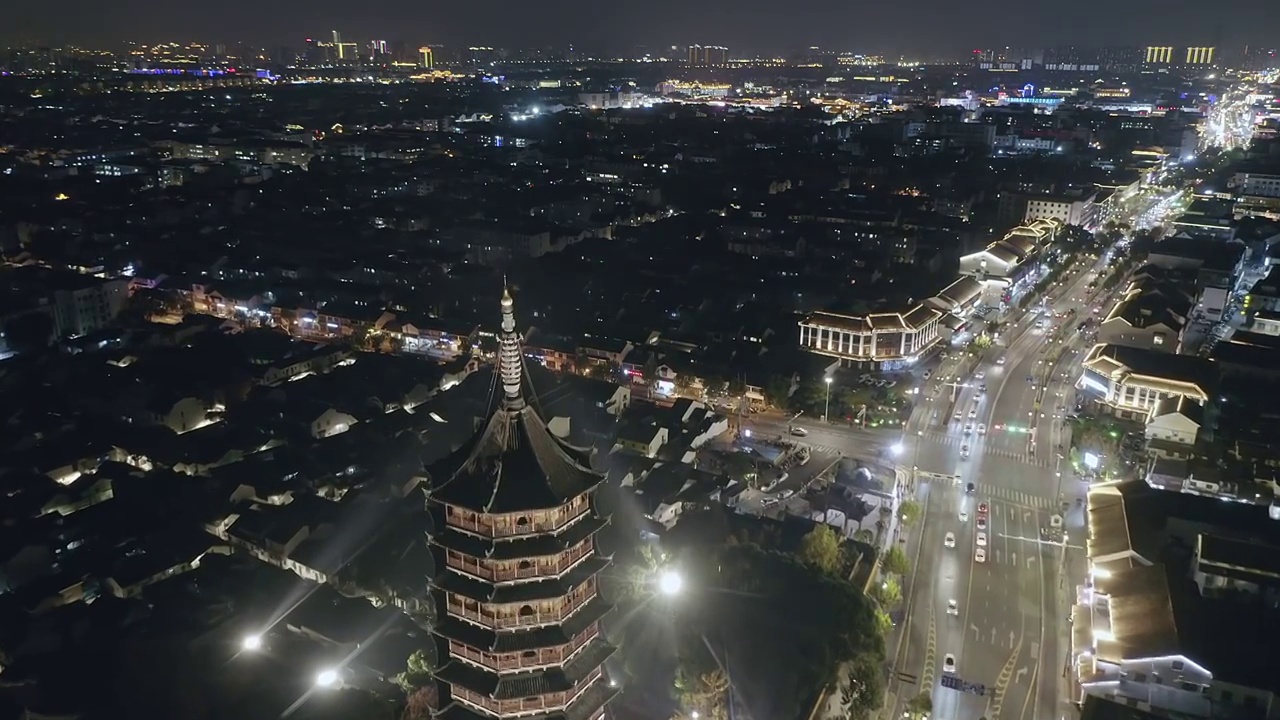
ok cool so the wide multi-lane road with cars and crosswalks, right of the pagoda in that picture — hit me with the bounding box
[886,251,1121,720]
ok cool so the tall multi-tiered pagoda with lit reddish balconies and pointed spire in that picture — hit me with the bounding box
[430,285,617,720]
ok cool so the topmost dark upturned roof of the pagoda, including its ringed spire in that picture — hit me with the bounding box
[429,284,603,514]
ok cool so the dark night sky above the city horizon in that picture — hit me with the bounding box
[0,0,1280,59]
